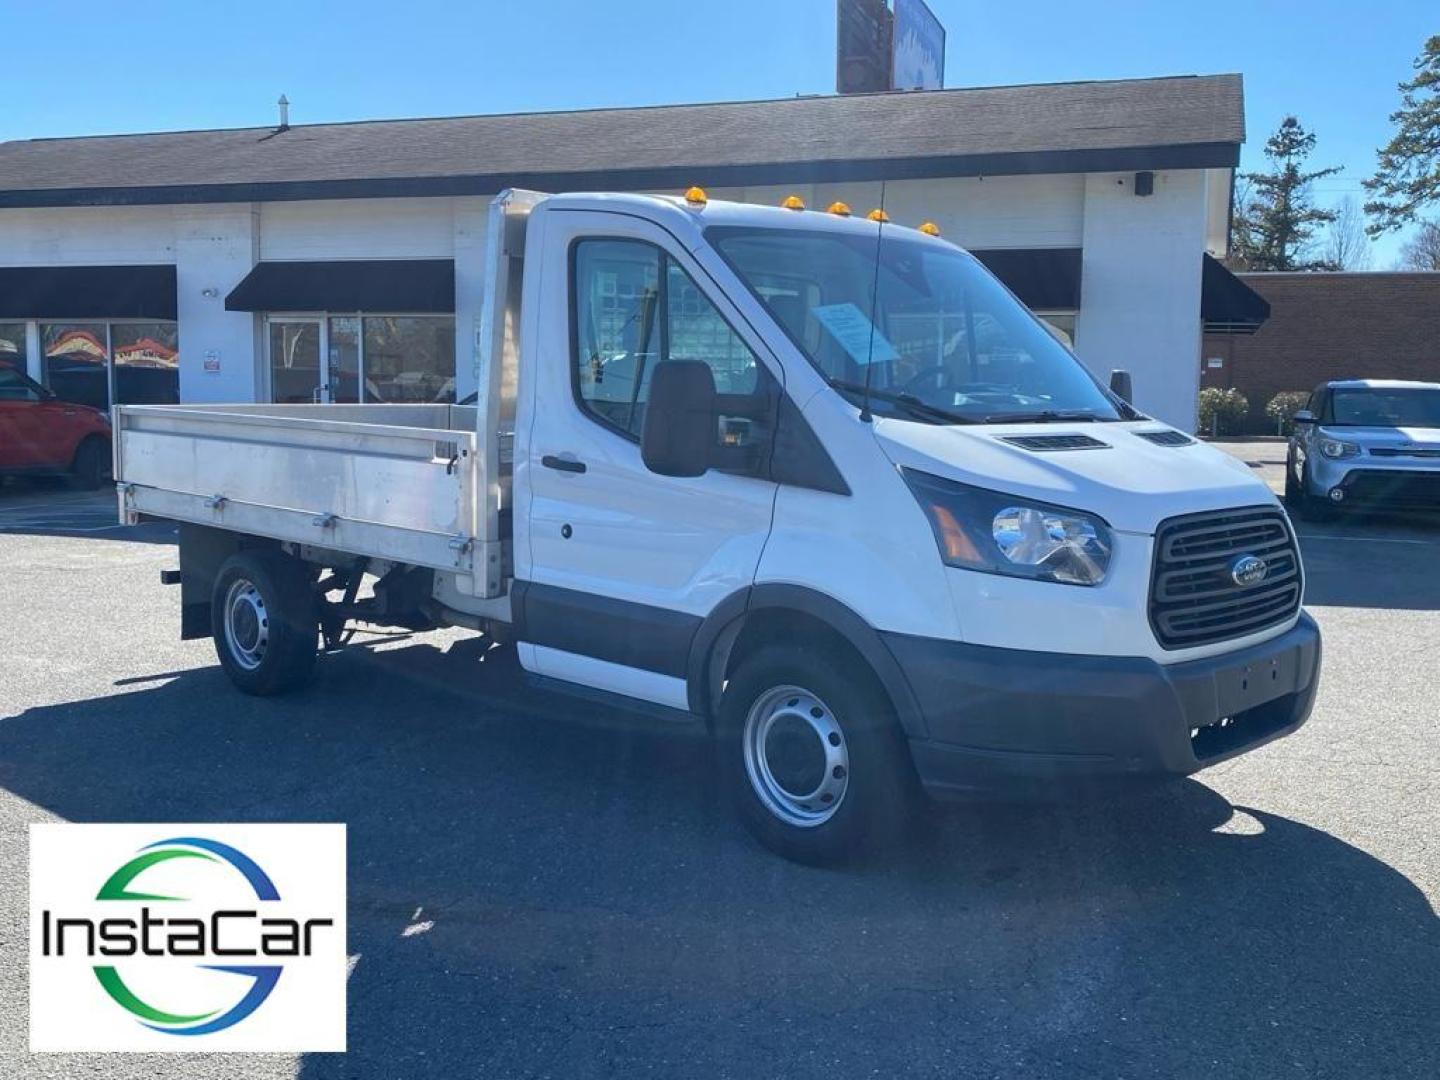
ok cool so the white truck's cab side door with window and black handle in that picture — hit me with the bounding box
[516,212,779,708]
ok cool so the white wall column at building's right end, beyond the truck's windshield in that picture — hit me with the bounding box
[1076,170,1207,431]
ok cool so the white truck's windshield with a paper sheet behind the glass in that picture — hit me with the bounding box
[706,226,1123,423]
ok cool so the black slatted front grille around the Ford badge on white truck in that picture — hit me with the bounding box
[1151,507,1300,649]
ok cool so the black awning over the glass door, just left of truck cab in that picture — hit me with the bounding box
[225,259,455,312]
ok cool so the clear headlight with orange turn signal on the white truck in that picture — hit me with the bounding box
[901,469,1112,585]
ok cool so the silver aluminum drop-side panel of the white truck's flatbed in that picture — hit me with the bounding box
[115,405,480,575]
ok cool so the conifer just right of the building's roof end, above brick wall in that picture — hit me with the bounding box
[1231,117,1341,271]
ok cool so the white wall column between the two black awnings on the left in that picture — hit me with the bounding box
[174,203,265,402]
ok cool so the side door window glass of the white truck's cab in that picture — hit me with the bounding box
[570,239,759,442]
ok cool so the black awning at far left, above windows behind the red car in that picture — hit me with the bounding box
[0,266,176,320]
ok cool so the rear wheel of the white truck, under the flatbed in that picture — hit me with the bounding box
[210,550,320,696]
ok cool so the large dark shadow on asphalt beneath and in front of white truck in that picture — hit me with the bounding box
[0,642,1440,1080]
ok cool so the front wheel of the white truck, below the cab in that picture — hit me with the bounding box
[719,645,917,864]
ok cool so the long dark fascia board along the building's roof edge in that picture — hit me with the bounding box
[0,143,1240,209]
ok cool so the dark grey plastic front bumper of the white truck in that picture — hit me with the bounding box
[884,612,1320,796]
